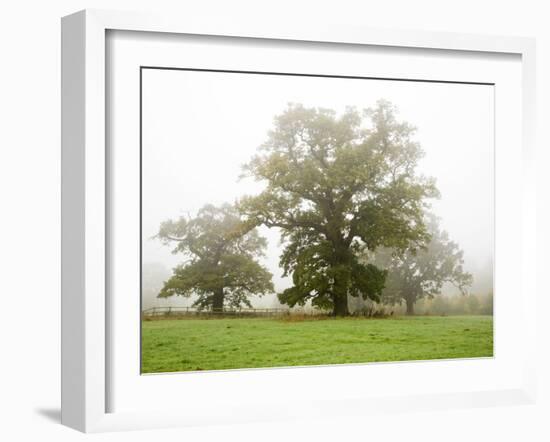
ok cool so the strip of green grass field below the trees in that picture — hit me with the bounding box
[142,316,493,373]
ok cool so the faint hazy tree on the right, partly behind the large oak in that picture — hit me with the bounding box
[375,216,473,315]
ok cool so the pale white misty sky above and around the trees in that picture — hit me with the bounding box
[142,69,494,304]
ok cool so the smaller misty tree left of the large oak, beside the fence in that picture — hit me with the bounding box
[157,204,274,311]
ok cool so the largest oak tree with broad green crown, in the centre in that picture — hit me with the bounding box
[240,100,437,316]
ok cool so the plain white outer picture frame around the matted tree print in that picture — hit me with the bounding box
[62,10,536,432]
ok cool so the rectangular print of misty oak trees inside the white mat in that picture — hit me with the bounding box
[140,67,494,373]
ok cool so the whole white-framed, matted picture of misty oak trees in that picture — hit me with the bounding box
[62,11,536,432]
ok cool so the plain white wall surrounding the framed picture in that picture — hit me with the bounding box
[0,0,550,441]
